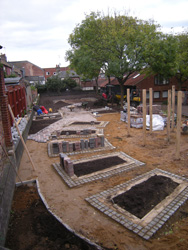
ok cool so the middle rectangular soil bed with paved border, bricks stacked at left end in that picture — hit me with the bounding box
[52,152,144,188]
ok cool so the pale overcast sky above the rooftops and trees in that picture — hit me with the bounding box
[0,0,188,68]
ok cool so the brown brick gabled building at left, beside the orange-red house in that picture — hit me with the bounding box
[9,61,45,85]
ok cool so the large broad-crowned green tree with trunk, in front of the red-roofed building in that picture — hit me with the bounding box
[67,13,176,105]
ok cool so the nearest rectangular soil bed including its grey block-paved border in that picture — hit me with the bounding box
[86,169,188,240]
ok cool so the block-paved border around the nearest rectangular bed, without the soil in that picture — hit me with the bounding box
[86,169,188,240]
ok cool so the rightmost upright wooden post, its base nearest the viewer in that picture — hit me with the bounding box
[176,91,182,160]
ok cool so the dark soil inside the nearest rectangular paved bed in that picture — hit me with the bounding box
[113,175,179,219]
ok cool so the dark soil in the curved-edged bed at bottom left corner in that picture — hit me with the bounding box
[6,185,96,250]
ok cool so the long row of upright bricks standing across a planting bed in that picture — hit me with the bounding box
[52,135,104,154]
